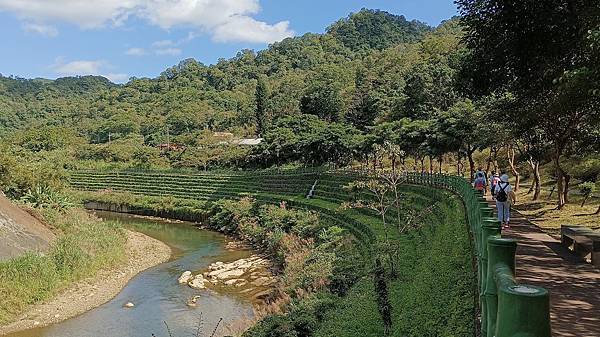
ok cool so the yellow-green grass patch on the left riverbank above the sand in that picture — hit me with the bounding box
[0,208,126,324]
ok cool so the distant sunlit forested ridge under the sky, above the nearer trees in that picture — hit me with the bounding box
[0,10,431,136]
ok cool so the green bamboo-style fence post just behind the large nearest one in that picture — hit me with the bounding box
[484,236,517,337]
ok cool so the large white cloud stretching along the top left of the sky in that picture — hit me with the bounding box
[0,0,294,43]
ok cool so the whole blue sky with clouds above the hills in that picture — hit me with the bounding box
[0,0,456,82]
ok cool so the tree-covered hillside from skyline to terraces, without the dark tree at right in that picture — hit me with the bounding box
[0,9,462,175]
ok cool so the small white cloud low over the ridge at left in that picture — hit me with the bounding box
[51,59,129,82]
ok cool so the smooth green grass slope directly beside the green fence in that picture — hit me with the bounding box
[315,193,474,337]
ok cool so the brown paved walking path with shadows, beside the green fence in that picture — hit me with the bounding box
[490,200,600,337]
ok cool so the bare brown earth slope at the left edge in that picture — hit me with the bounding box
[0,194,55,260]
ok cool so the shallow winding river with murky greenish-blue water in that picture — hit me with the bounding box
[8,212,253,337]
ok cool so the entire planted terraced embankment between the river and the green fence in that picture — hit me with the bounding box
[69,171,474,337]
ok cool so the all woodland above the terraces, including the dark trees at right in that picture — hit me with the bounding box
[0,0,600,207]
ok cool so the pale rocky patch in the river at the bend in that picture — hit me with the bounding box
[178,249,277,306]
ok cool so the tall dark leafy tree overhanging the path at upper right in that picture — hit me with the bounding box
[457,0,600,208]
